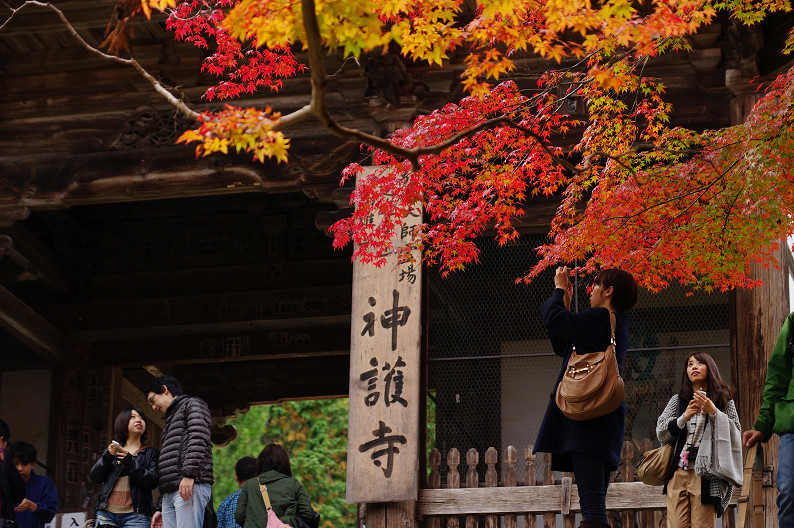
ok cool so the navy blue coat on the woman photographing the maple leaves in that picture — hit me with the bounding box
[535,288,629,471]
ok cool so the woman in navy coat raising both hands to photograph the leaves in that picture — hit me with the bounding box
[535,267,638,528]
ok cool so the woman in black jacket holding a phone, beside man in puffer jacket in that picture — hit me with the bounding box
[88,408,160,528]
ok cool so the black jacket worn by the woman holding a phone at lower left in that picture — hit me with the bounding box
[88,447,160,516]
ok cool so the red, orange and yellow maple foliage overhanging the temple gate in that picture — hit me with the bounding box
[136,0,794,290]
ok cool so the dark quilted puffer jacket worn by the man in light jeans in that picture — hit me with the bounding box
[157,394,215,493]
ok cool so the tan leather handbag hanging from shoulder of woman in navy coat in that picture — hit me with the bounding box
[555,312,624,421]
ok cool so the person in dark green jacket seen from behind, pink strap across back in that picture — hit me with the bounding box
[234,444,319,528]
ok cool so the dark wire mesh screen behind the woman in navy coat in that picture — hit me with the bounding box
[428,237,730,480]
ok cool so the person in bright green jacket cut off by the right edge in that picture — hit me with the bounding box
[742,312,794,528]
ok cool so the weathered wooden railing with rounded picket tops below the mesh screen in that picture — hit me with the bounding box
[416,439,763,528]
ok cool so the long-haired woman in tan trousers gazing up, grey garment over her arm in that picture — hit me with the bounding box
[656,352,742,528]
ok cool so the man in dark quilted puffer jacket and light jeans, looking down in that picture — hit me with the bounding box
[146,376,214,528]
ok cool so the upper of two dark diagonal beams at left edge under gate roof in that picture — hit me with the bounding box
[0,224,71,293]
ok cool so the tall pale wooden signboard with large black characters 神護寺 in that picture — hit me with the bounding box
[347,169,422,503]
